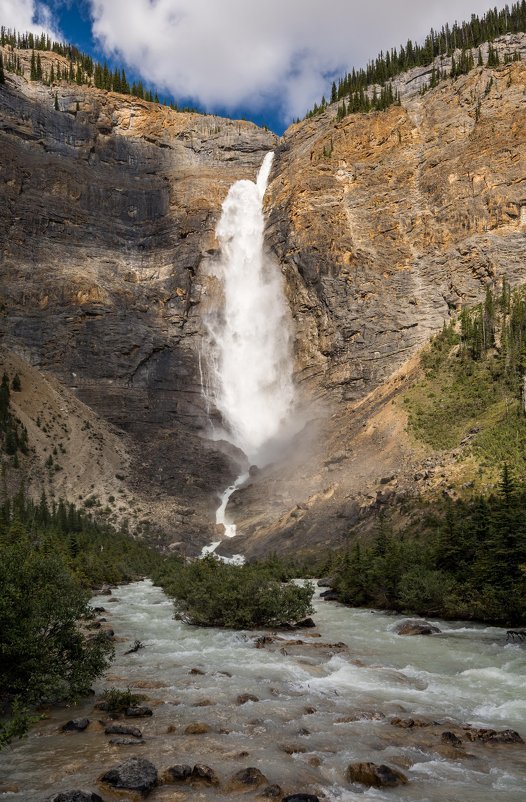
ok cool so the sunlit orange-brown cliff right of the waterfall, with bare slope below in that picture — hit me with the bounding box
[226,51,526,554]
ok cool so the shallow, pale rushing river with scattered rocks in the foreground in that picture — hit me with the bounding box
[0,582,526,802]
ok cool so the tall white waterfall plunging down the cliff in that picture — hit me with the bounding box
[206,153,294,465]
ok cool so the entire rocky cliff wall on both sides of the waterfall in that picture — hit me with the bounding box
[0,43,526,553]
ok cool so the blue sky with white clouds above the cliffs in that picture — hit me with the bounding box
[0,0,516,133]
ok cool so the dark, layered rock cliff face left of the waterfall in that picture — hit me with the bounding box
[0,54,276,542]
